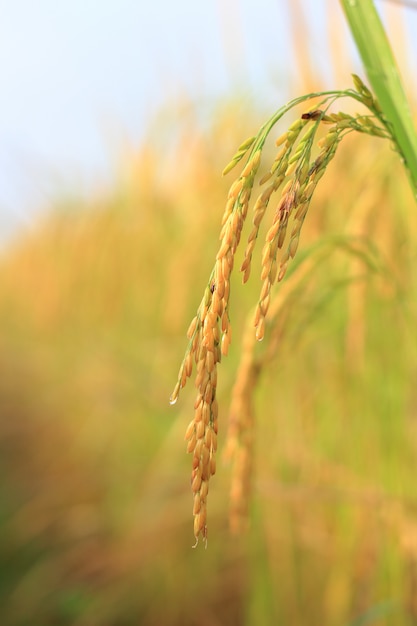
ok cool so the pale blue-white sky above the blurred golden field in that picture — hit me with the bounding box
[0,0,417,240]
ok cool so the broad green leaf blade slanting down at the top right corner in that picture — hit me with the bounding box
[340,0,417,196]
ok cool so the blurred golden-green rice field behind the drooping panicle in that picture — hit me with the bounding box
[0,6,417,626]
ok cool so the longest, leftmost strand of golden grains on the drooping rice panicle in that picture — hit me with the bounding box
[171,145,261,545]
